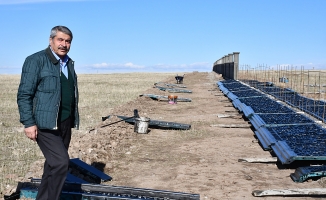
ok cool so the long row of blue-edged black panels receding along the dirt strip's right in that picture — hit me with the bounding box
[217,80,326,164]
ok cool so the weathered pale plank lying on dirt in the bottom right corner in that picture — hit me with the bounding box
[252,188,326,197]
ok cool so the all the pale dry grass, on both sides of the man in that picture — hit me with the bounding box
[0,73,175,194]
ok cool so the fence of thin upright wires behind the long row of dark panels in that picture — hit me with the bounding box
[238,65,326,122]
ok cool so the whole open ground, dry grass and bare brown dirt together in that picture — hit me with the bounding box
[0,72,325,200]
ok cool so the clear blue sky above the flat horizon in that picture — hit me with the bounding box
[0,0,326,74]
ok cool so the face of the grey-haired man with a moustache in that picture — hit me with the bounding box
[50,31,71,59]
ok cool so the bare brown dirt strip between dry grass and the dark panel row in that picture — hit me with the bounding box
[26,72,322,200]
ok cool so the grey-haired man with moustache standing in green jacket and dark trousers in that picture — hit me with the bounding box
[17,26,79,200]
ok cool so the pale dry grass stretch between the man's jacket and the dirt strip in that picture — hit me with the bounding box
[78,73,174,131]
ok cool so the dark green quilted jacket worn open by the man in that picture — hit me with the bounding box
[17,47,79,130]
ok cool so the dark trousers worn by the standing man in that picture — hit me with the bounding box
[36,118,71,200]
